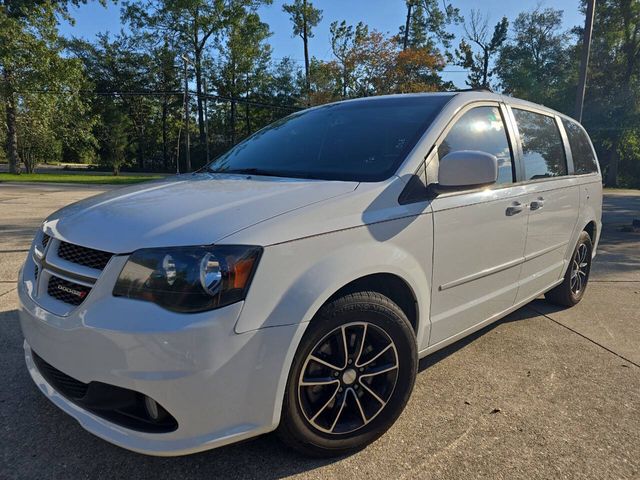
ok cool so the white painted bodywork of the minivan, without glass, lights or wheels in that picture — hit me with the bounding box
[18,93,602,455]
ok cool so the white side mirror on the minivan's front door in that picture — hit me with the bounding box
[438,150,498,190]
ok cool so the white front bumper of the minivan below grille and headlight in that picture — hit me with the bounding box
[18,264,304,456]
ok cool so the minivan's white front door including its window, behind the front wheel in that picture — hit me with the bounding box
[429,103,527,346]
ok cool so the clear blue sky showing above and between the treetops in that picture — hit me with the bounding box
[60,0,584,87]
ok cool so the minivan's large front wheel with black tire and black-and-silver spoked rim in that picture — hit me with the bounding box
[278,292,418,457]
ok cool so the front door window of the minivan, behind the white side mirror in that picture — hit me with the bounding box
[438,107,513,183]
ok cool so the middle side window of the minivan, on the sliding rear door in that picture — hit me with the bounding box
[513,108,567,180]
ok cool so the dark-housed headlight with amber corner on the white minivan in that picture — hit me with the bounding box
[113,245,262,313]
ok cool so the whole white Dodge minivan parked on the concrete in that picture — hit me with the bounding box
[18,91,602,456]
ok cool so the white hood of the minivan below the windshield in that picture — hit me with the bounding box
[44,173,358,253]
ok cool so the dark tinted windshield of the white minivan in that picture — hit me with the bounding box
[207,95,451,182]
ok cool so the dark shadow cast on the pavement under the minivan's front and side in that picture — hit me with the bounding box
[0,307,552,479]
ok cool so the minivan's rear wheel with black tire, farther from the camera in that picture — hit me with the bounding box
[544,231,593,307]
